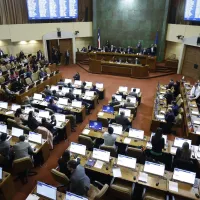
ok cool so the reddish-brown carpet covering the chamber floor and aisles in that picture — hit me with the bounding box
[11,65,193,200]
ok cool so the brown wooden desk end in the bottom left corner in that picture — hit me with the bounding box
[0,171,15,200]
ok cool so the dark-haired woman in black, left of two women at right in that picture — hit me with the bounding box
[150,128,165,156]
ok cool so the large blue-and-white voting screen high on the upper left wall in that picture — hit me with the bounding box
[27,0,78,20]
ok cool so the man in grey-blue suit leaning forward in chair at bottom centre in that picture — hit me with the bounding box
[67,160,90,197]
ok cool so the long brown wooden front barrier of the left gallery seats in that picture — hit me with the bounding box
[16,73,62,104]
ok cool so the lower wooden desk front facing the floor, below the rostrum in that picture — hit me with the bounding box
[89,59,149,78]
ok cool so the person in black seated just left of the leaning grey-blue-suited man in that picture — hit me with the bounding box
[58,150,71,178]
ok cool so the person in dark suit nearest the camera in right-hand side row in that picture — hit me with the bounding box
[163,108,175,134]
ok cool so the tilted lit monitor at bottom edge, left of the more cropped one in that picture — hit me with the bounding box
[36,181,57,200]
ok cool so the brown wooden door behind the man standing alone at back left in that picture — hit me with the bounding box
[59,39,73,65]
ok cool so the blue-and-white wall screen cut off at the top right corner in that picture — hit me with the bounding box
[184,0,200,21]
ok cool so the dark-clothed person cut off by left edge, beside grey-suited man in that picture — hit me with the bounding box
[0,133,10,160]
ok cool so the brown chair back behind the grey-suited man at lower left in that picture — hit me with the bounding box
[12,157,33,174]
